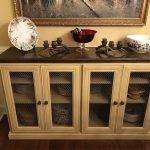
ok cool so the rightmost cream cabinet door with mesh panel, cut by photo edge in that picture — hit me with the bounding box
[117,65,150,133]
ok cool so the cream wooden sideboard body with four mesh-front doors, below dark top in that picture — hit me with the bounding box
[1,63,150,139]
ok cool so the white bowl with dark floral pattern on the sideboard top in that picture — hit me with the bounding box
[127,34,150,53]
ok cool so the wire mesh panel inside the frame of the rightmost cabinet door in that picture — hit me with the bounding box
[122,72,150,129]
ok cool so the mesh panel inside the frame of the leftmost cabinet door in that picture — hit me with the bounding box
[9,72,38,127]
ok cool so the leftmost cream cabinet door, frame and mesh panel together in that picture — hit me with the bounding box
[2,66,43,132]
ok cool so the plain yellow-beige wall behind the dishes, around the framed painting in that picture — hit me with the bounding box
[0,0,150,46]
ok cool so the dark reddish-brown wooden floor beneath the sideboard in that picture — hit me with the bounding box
[0,117,150,150]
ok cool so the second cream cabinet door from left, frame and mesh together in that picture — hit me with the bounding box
[42,64,81,132]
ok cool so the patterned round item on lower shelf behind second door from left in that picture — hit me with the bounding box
[52,104,72,125]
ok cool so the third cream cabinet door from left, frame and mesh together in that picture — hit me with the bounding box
[82,64,121,133]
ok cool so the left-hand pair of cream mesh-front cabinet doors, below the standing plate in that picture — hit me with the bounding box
[1,64,81,133]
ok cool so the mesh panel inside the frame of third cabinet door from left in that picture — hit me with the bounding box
[89,72,114,127]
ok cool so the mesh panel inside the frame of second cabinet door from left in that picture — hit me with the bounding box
[49,72,73,127]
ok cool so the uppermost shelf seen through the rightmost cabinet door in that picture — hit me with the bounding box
[130,76,150,84]
